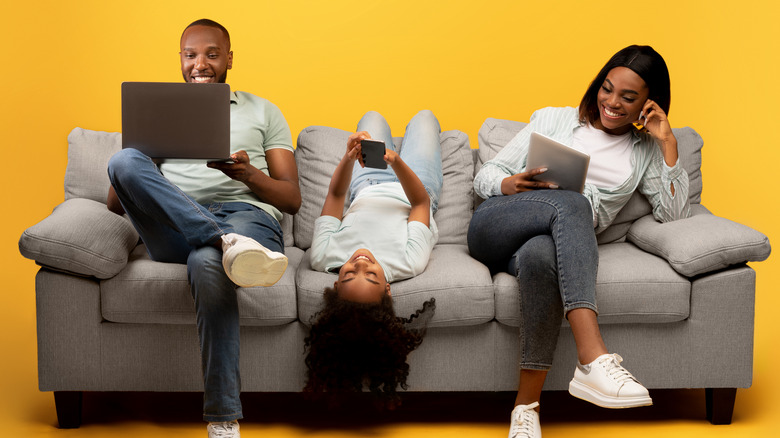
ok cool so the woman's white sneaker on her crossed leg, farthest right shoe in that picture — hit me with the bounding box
[569,354,653,408]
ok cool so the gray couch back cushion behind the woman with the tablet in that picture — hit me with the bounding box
[475,118,704,244]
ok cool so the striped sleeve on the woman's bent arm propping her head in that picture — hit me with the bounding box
[638,145,691,222]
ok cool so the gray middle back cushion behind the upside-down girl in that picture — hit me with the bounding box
[293,126,474,250]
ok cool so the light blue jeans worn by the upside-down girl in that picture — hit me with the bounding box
[349,110,444,212]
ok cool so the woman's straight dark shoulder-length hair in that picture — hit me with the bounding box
[580,45,672,124]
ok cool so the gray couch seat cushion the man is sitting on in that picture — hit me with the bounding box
[100,245,303,326]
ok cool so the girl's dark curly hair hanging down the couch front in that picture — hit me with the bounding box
[304,288,436,409]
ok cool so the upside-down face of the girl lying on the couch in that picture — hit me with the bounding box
[333,248,390,303]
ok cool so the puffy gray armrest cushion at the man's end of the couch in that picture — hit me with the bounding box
[19,198,138,279]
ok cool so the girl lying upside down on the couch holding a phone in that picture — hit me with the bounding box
[306,111,443,407]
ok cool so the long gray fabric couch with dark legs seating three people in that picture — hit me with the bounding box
[19,119,770,427]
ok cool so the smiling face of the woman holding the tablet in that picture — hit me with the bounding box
[594,67,650,135]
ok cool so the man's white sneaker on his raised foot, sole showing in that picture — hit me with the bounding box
[222,233,287,287]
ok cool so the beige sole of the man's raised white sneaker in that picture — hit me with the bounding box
[223,251,287,287]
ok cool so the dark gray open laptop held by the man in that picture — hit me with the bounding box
[122,82,230,161]
